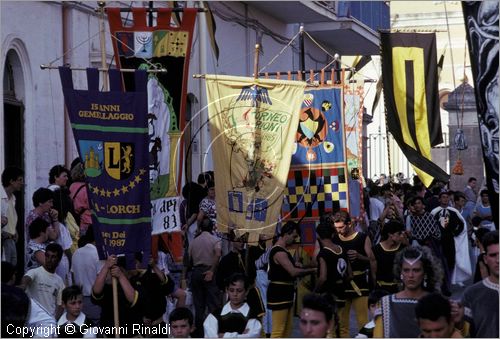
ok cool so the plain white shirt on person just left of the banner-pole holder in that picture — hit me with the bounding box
[71,244,104,297]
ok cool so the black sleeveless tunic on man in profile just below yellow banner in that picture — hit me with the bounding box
[267,246,295,310]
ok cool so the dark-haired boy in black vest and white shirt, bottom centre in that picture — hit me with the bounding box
[203,273,262,338]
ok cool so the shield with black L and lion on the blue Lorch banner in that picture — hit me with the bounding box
[104,142,135,180]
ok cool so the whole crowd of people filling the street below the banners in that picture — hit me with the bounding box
[1,164,499,338]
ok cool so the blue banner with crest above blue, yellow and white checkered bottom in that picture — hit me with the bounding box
[282,87,349,219]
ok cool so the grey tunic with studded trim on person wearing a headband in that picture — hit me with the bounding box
[374,294,420,338]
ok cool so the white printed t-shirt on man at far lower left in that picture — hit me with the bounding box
[25,266,65,316]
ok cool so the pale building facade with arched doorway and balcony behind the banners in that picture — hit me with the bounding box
[0,1,382,238]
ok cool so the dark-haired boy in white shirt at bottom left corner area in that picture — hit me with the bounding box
[57,285,96,338]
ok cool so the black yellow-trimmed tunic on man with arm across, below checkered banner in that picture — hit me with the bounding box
[333,232,370,298]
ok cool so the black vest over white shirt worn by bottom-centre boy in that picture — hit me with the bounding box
[203,302,262,338]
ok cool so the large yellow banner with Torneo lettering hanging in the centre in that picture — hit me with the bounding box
[205,75,306,243]
